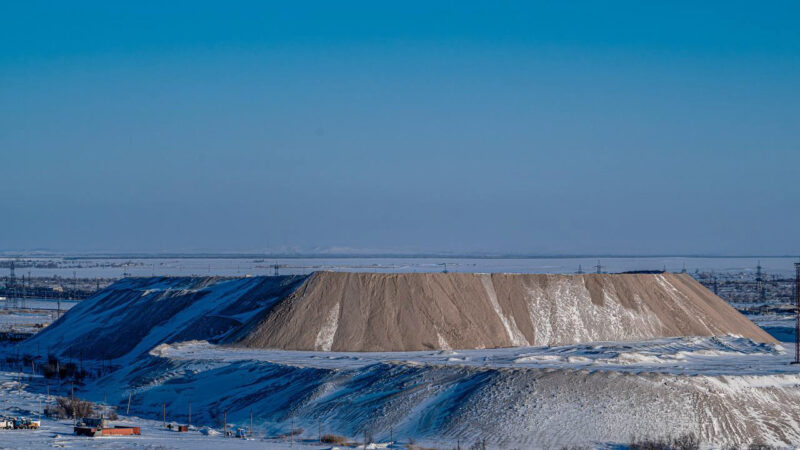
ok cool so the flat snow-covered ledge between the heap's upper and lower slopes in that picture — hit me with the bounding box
[151,336,800,376]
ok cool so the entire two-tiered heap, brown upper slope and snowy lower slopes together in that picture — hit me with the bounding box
[15,272,800,448]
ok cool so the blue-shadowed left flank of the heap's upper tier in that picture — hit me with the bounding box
[25,276,306,359]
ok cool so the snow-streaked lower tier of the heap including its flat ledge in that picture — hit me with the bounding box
[3,336,800,448]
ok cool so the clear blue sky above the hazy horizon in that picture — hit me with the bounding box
[0,0,800,255]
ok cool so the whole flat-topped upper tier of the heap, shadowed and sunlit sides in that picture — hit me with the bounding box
[26,272,775,359]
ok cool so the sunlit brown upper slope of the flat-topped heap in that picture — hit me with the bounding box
[226,272,776,351]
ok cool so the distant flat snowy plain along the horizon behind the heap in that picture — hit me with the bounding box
[0,256,797,278]
